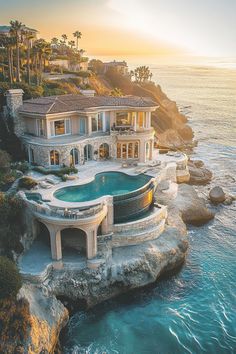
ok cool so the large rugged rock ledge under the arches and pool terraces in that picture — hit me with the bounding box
[48,226,188,307]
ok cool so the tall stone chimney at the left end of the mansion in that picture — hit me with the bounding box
[5,89,24,136]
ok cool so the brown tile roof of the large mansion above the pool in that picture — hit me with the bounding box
[19,95,158,114]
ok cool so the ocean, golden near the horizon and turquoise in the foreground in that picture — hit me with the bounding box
[61,61,236,354]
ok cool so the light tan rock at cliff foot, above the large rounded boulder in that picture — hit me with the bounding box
[188,160,212,185]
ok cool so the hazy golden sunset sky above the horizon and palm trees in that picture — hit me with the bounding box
[0,0,236,57]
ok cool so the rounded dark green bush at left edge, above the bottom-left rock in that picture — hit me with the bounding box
[0,256,22,299]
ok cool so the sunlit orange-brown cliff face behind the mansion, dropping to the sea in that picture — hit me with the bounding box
[90,72,194,149]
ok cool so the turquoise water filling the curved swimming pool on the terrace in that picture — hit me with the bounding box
[54,172,151,202]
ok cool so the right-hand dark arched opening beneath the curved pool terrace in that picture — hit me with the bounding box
[61,228,87,258]
